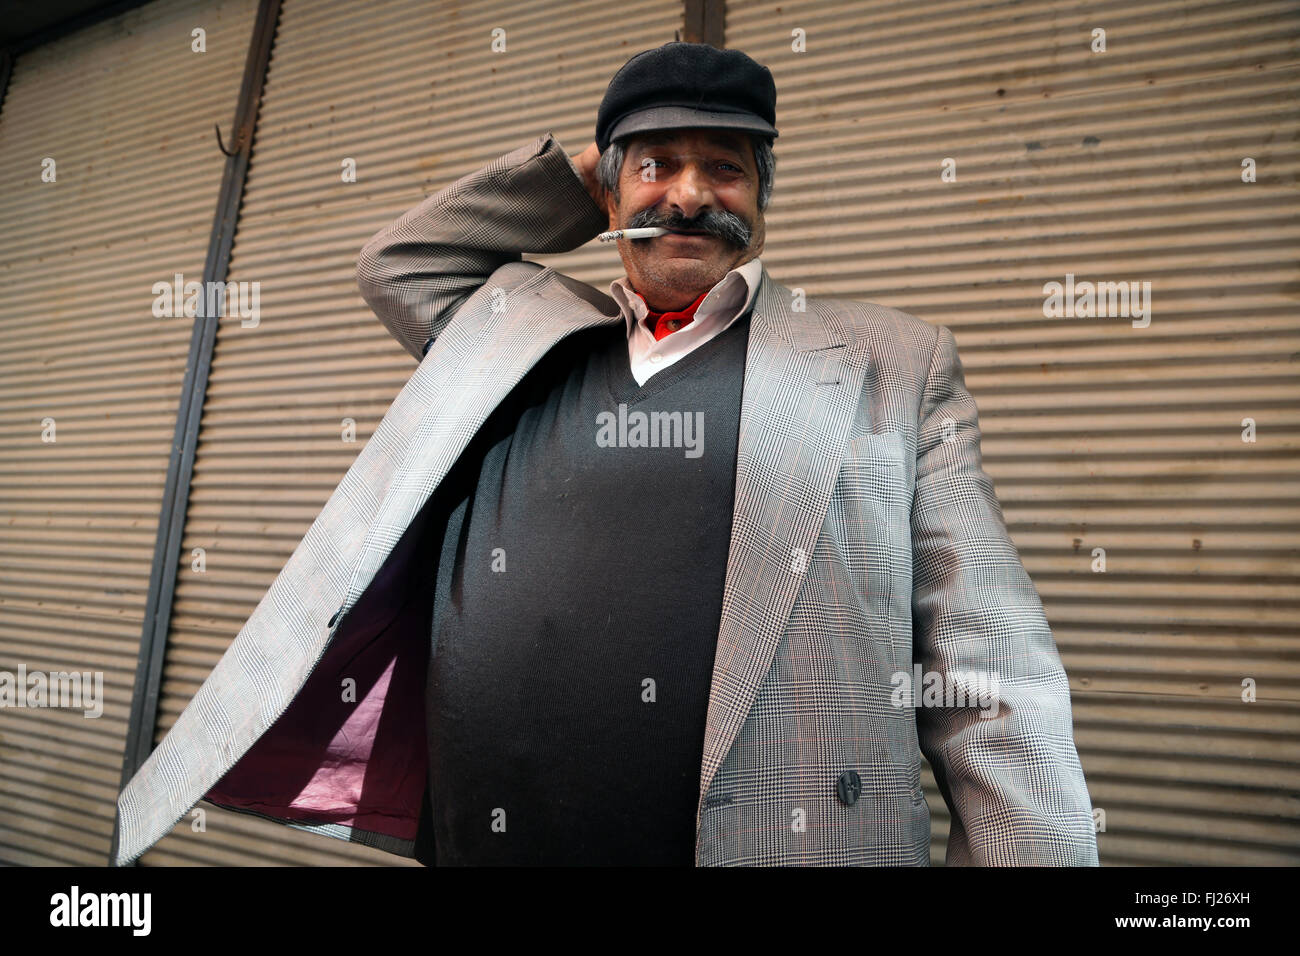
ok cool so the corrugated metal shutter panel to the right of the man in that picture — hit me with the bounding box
[727,0,1300,865]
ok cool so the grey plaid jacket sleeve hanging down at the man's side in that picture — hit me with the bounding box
[911,325,1097,866]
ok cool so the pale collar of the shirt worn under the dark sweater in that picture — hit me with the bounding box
[610,258,763,385]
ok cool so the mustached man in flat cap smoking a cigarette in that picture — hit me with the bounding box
[117,43,1097,865]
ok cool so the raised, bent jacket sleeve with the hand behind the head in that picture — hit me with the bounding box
[356,133,608,360]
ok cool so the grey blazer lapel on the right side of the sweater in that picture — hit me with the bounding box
[697,269,868,822]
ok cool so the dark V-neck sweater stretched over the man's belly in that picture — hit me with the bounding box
[426,317,749,866]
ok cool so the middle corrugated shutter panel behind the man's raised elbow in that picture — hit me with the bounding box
[142,0,681,865]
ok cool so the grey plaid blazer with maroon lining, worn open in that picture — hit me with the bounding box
[114,128,1097,865]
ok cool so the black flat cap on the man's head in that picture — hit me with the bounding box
[595,40,779,152]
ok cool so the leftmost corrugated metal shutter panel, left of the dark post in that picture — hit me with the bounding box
[0,0,255,866]
